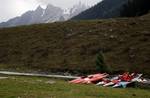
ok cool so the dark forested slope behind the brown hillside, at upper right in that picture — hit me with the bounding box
[72,0,150,20]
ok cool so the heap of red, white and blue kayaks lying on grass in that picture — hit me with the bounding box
[69,72,146,88]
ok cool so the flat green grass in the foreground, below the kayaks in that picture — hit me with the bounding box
[0,77,150,98]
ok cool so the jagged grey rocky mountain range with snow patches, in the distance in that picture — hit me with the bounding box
[0,3,89,27]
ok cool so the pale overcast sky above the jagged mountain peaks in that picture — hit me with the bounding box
[0,0,101,22]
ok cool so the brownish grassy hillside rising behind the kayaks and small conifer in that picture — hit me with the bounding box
[0,15,150,75]
